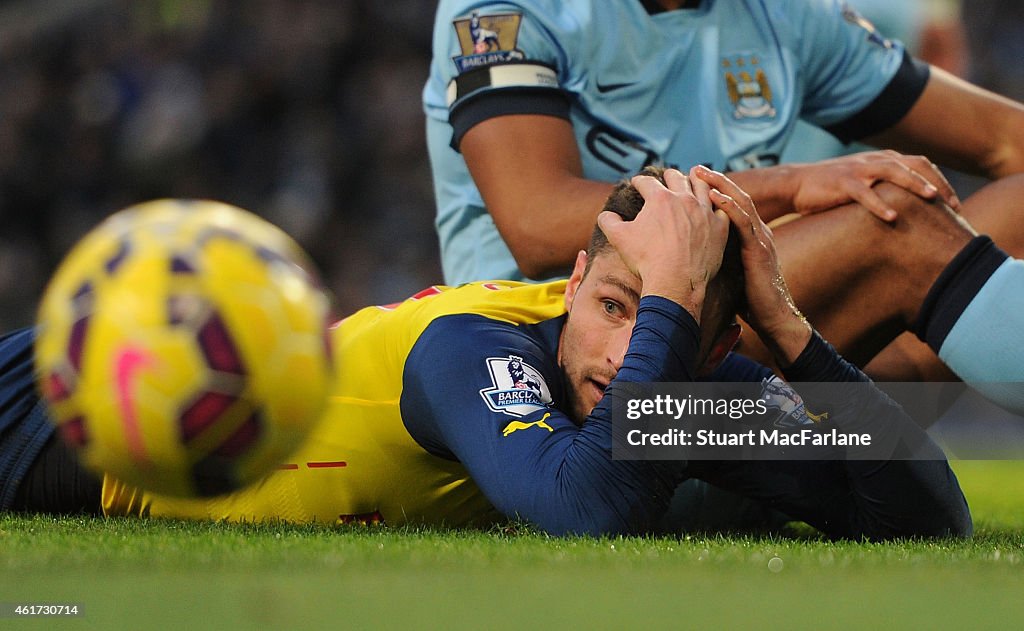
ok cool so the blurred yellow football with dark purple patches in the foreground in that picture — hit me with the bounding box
[35,200,333,497]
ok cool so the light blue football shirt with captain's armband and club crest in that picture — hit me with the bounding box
[423,0,928,284]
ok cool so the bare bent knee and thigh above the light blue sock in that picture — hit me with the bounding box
[740,183,975,366]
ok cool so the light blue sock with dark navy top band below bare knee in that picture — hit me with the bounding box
[914,237,1024,414]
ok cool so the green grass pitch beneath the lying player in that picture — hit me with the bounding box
[0,461,1024,629]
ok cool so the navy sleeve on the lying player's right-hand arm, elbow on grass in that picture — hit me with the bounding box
[765,333,972,539]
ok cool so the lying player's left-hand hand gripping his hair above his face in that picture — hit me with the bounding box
[598,169,729,321]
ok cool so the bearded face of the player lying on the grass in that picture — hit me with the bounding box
[558,249,641,423]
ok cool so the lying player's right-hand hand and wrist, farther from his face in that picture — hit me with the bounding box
[692,166,811,364]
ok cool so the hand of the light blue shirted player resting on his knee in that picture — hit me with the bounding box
[793,150,961,221]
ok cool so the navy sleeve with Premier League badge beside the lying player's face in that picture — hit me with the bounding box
[401,297,699,535]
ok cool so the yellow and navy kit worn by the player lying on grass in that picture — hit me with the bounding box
[0,282,971,538]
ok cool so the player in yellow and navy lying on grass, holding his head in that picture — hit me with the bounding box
[0,165,972,539]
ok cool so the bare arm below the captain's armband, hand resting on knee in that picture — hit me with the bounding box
[460,115,955,279]
